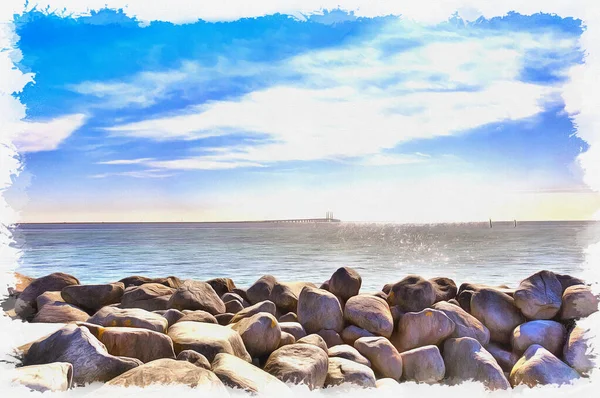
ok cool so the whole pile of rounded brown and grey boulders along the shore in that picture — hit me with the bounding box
[4,267,599,393]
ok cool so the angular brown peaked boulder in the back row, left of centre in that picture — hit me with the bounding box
[167,279,225,315]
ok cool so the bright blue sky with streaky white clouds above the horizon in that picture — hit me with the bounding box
[7,10,600,223]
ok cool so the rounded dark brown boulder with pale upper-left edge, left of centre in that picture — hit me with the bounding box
[231,312,281,358]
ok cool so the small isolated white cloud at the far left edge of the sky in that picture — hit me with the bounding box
[10,114,86,152]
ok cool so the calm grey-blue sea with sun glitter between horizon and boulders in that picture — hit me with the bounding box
[8,222,600,291]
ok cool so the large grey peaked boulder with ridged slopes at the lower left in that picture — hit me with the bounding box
[23,324,141,384]
